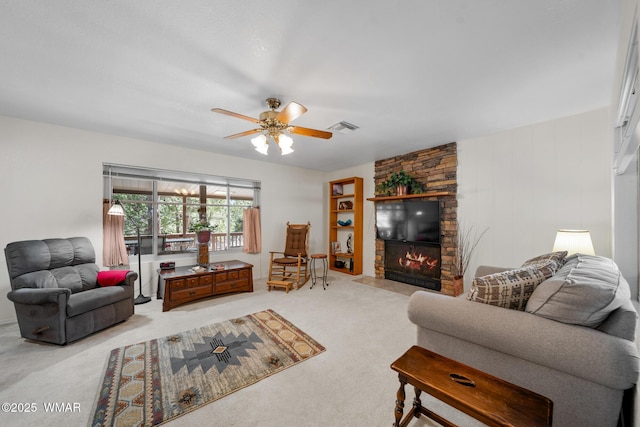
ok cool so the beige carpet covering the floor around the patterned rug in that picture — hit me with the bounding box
[0,271,480,427]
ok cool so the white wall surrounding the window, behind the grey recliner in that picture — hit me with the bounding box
[0,116,327,323]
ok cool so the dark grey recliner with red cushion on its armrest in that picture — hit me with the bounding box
[5,237,138,344]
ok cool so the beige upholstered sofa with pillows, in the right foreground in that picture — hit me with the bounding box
[408,255,638,427]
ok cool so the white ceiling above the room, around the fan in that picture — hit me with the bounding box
[0,0,620,171]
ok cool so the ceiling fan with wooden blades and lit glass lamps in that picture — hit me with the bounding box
[211,98,333,155]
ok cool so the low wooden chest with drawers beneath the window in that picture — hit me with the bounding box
[157,260,253,311]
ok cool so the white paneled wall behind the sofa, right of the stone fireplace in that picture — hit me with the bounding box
[458,109,612,289]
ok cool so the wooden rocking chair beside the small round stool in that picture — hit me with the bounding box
[267,222,311,292]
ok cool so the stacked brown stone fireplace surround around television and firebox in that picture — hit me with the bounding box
[375,142,458,295]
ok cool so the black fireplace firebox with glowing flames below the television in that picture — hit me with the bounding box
[384,240,441,291]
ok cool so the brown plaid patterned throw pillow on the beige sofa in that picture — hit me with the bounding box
[467,261,557,311]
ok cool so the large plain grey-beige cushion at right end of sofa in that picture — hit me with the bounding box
[526,254,631,328]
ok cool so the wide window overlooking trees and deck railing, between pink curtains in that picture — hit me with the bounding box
[103,164,260,255]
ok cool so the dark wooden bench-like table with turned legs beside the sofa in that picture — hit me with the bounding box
[391,346,553,427]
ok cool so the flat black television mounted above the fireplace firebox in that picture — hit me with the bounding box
[376,200,440,243]
